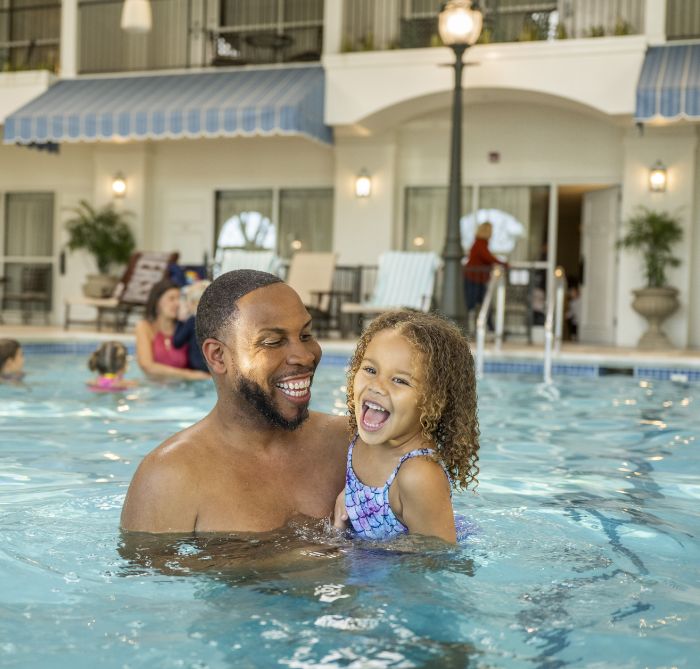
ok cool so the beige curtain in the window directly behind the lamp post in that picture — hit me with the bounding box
[403,186,472,253]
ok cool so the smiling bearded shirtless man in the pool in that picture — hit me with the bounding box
[121,270,347,534]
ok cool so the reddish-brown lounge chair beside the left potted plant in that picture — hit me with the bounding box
[63,251,179,331]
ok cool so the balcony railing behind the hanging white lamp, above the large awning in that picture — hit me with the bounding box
[79,0,323,73]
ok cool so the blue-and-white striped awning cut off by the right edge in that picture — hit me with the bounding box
[635,44,700,122]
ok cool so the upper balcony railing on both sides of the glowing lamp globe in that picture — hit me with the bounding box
[341,0,645,52]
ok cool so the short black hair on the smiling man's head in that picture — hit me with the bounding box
[196,269,282,348]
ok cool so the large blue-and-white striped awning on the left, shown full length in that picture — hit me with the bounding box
[4,66,333,145]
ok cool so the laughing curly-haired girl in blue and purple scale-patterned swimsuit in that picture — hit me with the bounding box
[335,310,479,543]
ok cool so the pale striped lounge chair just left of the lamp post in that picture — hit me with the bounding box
[340,251,440,334]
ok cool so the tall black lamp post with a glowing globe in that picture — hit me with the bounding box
[438,0,483,326]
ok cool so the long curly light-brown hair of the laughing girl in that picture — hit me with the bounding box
[347,309,479,488]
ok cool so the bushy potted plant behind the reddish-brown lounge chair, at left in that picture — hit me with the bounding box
[66,200,136,297]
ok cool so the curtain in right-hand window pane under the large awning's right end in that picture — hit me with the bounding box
[278,188,333,258]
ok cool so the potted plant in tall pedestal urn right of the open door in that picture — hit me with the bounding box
[618,207,683,349]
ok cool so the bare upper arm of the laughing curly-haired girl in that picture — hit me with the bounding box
[392,458,457,544]
